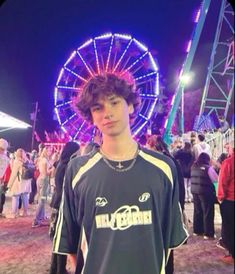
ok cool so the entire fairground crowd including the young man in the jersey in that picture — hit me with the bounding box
[0,74,234,274]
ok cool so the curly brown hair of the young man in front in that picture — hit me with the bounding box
[77,73,140,122]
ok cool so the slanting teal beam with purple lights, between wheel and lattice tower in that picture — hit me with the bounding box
[164,0,211,144]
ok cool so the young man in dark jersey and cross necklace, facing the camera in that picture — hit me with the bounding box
[53,74,188,274]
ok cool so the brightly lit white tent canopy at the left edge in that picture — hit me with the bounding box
[0,111,31,132]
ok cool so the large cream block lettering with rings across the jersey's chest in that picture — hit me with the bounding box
[95,205,152,230]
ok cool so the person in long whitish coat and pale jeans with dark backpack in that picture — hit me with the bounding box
[8,148,31,218]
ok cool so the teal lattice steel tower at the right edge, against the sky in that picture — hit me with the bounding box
[199,0,234,126]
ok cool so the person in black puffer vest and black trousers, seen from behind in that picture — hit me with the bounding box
[191,152,218,240]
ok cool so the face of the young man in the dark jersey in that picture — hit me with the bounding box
[90,94,134,136]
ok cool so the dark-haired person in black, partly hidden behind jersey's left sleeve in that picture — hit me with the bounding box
[49,142,79,274]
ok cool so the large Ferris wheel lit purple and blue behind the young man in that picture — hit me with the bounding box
[54,33,159,142]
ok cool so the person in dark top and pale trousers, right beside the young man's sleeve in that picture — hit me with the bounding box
[174,142,194,203]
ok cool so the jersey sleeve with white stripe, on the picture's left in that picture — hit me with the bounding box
[53,163,81,254]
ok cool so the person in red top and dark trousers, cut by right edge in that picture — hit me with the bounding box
[217,142,235,264]
